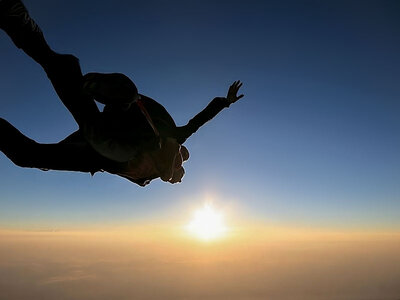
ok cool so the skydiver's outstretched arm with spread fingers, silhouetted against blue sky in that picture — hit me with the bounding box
[176,80,244,144]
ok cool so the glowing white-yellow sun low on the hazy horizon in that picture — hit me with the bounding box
[186,204,227,241]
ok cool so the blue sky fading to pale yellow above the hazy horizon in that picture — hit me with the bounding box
[0,0,400,230]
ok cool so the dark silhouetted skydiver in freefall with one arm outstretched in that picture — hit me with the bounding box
[0,0,243,186]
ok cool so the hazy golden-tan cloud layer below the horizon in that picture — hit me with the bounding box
[0,230,400,300]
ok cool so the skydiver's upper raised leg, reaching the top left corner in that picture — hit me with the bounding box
[0,0,99,127]
